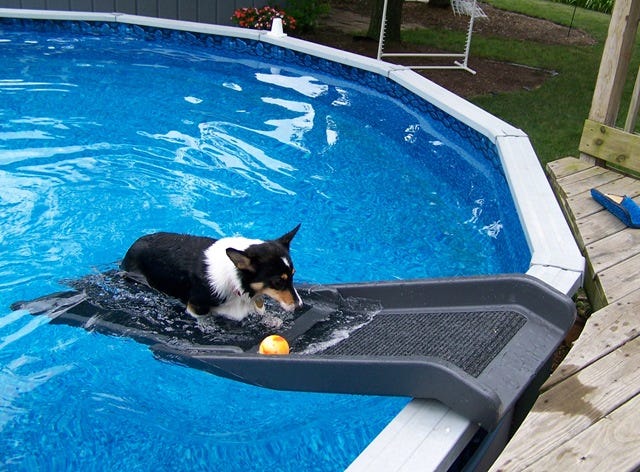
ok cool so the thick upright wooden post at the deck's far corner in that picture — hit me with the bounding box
[589,0,640,126]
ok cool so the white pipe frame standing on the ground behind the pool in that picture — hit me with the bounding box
[378,0,487,74]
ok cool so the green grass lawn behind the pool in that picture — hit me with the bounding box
[403,0,640,164]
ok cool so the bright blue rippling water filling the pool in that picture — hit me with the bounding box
[0,21,530,471]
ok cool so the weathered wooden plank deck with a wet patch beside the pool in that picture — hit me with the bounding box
[491,157,640,472]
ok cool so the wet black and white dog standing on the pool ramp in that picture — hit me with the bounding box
[121,225,302,321]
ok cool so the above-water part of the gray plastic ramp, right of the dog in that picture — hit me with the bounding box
[153,275,575,430]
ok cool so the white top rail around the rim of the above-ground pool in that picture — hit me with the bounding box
[0,8,585,472]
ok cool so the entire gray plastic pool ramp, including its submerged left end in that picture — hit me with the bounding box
[13,271,575,430]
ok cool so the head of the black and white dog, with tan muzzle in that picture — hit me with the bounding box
[227,225,302,311]
